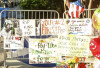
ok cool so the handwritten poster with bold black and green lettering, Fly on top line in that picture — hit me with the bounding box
[29,39,57,64]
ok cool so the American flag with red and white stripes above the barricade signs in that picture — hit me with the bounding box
[65,0,84,18]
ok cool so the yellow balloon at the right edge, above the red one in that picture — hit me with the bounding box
[92,9,100,30]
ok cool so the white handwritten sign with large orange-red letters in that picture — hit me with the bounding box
[41,19,66,35]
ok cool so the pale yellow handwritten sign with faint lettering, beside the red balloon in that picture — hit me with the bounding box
[58,35,90,57]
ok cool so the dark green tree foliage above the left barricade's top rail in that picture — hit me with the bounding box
[20,0,64,17]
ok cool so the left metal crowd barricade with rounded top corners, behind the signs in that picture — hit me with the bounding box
[0,10,59,68]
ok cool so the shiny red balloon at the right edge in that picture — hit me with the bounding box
[90,37,100,60]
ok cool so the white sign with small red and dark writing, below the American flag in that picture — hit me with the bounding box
[67,19,92,35]
